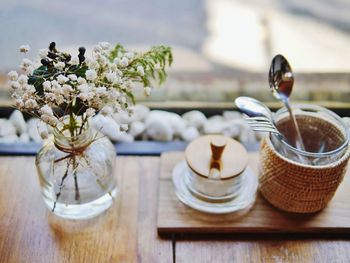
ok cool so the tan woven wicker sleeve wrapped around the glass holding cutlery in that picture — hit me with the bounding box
[259,137,350,213]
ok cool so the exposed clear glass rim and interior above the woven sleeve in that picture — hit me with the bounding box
[270,104,349,166]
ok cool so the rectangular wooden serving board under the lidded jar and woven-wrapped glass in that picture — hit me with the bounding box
[157,152,350,234]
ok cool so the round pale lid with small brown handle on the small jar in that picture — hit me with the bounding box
[185,135,248,180]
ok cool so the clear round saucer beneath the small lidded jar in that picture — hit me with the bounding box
[172,161,258,214]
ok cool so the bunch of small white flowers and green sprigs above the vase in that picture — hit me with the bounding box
[8,42,173,137]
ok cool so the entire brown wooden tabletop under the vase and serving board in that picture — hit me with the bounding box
[0,157,350,263]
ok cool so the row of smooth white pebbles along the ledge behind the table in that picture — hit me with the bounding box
[0,110,266,143]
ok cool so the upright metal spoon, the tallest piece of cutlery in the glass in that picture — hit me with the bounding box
[269,55,305,151]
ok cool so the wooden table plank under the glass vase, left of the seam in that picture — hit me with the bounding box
[0,157,172,263]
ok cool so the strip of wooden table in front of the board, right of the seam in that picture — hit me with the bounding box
[176,239,350,263]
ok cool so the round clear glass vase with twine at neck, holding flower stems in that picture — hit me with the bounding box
[36,122,117,219]
